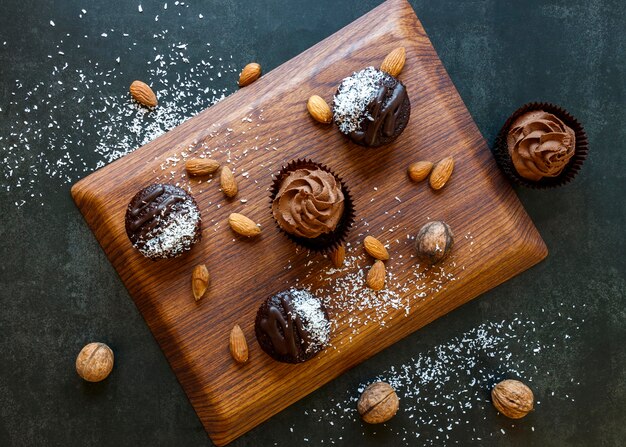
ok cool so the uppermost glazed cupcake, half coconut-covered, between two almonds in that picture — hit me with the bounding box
[333,67,411,147]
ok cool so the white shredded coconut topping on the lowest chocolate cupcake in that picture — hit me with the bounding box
[289,289,330,352]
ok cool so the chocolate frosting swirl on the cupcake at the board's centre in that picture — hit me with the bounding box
[272,168,345,239]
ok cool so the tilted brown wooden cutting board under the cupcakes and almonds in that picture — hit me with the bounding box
[72,0,547,445]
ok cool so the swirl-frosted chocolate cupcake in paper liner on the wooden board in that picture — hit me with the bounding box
[271,160,354,252]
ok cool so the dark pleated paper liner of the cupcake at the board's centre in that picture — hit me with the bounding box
[270,159,355,253]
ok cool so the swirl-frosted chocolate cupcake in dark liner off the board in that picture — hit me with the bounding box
[494,103,587,188]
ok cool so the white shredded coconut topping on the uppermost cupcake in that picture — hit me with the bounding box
[333,67,385,134]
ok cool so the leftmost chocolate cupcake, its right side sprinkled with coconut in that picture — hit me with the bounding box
[126,183,202,260]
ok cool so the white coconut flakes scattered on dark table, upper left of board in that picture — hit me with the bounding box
[0,10,238,206]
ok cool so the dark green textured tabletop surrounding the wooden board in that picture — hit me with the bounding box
[0,0,626,447]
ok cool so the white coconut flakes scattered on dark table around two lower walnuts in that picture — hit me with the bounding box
[275,303,587,446]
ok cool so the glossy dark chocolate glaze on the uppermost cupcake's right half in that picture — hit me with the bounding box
[349,81,407,146]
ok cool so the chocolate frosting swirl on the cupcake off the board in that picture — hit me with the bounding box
[507,110,576,181]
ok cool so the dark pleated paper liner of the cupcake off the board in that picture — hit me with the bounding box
[492,102,588,189]
